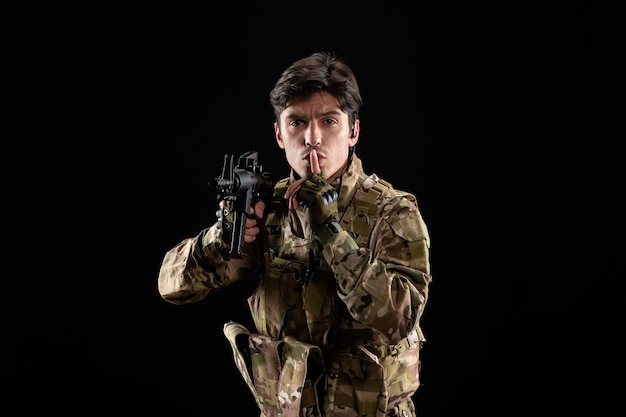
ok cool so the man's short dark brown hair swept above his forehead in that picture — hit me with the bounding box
[270,52,363,123]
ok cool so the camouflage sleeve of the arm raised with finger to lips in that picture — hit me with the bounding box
[324,197,431,340]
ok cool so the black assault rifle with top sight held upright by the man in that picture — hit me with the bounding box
[209,151,274,258]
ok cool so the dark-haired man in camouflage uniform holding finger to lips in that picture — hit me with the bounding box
[158,53,431,417]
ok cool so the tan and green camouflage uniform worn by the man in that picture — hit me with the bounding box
[158,156,431,417]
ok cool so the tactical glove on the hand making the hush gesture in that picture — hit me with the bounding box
[296,174,339,233]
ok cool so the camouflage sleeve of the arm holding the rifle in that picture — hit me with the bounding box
[158,225,260,304]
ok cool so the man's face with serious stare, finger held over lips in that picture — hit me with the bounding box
[274,92,359,182]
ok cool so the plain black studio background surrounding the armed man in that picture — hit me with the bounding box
[2,1,623,417]
